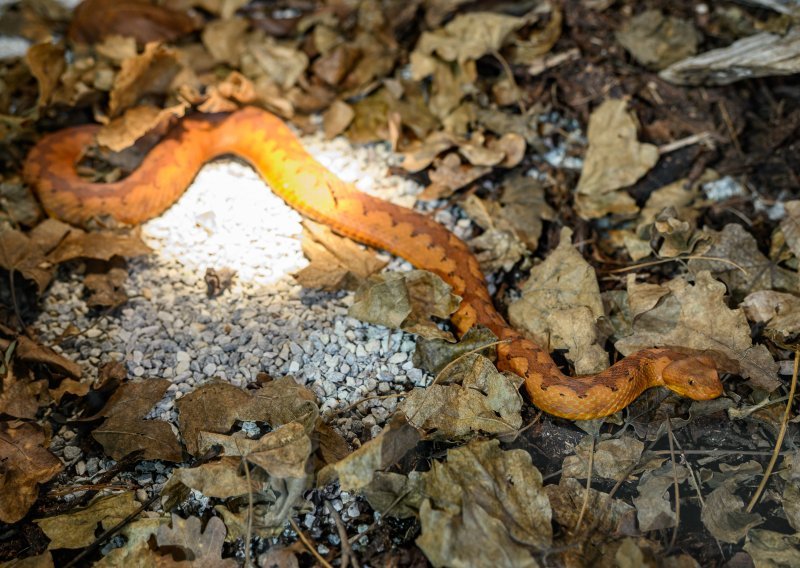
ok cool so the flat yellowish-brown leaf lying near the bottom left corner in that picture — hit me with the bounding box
[34,491,139,550]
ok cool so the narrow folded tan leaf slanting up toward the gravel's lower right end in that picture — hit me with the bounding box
[317,412,421,491]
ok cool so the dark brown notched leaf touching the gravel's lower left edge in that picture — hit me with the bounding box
[92,379,183,462]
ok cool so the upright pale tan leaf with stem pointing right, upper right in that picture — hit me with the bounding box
[575,99,658,219]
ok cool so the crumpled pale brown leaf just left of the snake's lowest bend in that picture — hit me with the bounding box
[399,353,522,441]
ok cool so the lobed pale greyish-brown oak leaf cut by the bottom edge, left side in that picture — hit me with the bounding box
[156,513,239,568]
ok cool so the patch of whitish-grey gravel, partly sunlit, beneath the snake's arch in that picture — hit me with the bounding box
[36,130,476,441]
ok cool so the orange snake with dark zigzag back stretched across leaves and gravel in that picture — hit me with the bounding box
[25,108,722,419]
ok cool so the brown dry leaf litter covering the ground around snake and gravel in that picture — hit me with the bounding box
[0,0,800,566]
